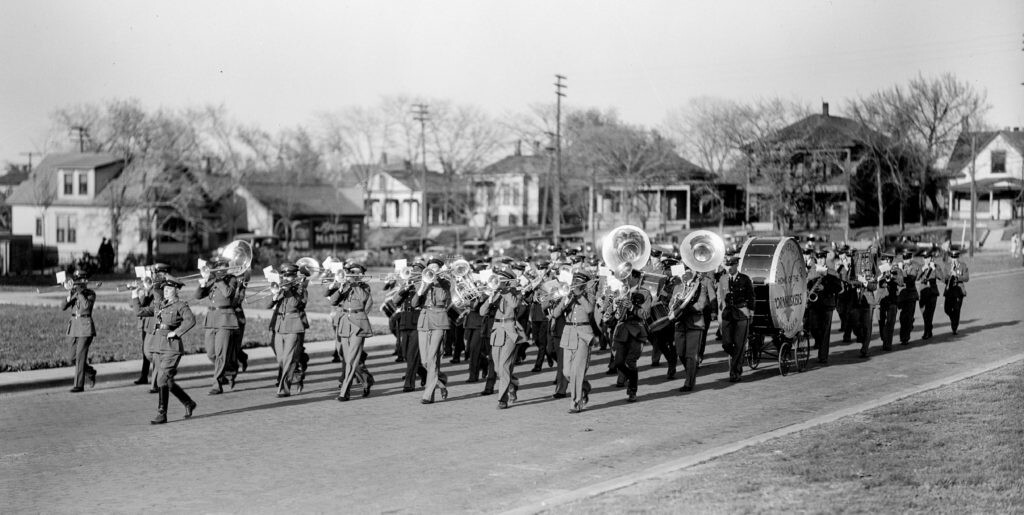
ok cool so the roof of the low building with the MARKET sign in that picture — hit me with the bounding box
[243,177,364,216]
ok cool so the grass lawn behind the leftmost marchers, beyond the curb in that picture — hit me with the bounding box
[0,305,334,372]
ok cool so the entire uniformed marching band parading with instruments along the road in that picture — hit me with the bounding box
[49,226,970,424]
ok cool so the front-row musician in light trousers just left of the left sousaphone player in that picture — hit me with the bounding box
[552,272,596,413]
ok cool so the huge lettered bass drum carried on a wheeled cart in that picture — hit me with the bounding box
[739,238,807,338]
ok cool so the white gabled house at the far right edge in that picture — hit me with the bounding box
[946,127,1024,220]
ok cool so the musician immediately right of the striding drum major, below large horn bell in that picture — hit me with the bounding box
[195,259,239,395]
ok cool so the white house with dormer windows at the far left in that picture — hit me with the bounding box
[7,153,145,264]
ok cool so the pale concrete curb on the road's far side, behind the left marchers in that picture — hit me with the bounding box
[0,335,394,394]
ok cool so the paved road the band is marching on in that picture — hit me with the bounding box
[0,273,1024,513]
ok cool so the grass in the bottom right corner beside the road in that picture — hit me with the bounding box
[555,362,1024,514]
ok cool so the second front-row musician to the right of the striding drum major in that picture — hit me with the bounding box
[267,263,309,397]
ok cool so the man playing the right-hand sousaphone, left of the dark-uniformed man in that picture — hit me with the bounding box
[669,270,711,392]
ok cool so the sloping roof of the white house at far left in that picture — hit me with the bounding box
[7,153,122,206]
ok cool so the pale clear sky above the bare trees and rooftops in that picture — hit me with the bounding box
[0,0,1024,163]
